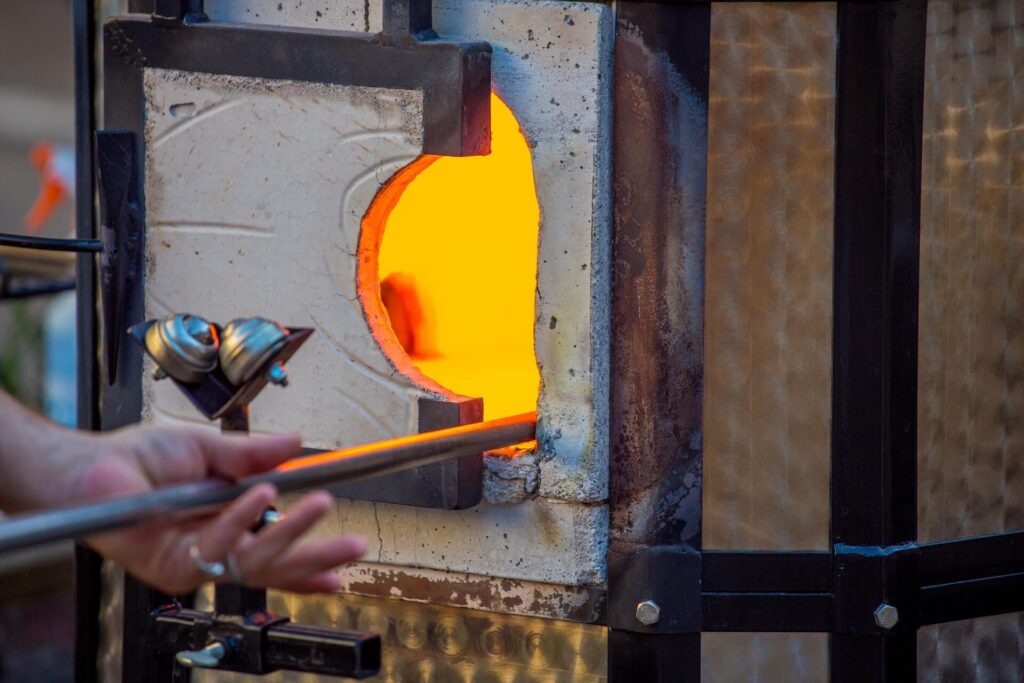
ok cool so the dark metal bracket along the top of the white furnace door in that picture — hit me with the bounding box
[103,0,490,157]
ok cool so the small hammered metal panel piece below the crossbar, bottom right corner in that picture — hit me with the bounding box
[918,613,1024,683]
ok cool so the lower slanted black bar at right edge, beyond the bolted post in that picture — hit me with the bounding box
[919,572,1024,626]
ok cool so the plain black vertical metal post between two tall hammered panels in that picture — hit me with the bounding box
[829,0,927,683]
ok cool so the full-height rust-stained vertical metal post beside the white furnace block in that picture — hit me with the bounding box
[608,2,711,682]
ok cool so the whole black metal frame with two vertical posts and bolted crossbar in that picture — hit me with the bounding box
[608,0,1024,682]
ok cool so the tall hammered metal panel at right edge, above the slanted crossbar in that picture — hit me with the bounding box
[918,0,1024,542]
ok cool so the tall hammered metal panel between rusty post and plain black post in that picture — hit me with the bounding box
[703,3,836,550]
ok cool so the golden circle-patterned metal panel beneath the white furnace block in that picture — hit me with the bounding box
[193,592,608,683]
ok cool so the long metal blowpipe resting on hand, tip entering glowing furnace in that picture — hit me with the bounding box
[0,413,537,553]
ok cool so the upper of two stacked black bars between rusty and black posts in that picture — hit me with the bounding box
[700,550,831,593]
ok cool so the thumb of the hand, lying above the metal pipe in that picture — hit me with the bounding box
[193,430,302,479]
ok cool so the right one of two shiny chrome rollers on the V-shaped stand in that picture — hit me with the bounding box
[219,317,288,386]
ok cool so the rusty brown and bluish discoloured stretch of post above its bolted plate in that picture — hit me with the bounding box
[609,12,708,545]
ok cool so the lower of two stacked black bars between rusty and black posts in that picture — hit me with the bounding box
[701,593,833,633]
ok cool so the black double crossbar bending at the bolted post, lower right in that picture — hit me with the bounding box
[675,531,1024,637]
